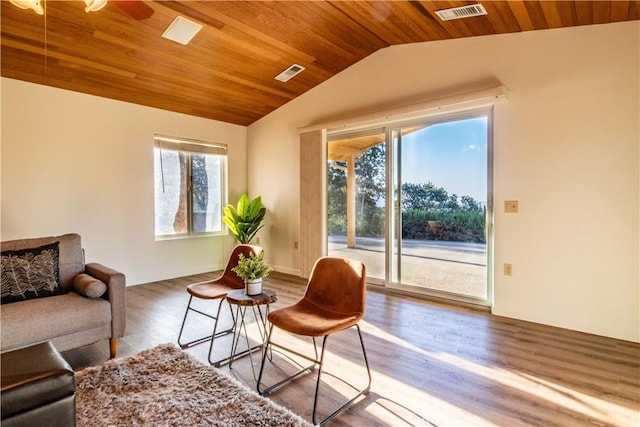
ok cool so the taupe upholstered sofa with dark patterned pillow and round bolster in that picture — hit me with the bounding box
[0,234,126,358]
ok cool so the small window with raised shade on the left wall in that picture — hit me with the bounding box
[154,135,227,239]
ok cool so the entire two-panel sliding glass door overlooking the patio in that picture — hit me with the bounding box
[327,111,491,304]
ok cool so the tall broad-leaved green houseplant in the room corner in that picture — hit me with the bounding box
[222,194,267,244]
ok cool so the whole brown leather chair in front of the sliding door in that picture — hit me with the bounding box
[257,257,371,425]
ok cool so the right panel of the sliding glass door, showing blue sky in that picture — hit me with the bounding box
[389,115,489,302]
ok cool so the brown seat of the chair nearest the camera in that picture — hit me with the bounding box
[269,298,363,337]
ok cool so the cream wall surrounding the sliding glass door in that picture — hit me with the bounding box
[248,21,640,342]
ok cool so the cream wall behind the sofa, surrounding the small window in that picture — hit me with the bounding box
[1,78,247,284]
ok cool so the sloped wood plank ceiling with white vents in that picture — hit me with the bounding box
[0,0,640,125]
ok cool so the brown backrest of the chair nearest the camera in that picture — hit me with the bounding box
[304,257,367,320]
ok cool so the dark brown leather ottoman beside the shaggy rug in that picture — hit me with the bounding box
[0,342,76,427]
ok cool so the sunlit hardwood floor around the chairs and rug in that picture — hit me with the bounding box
[63,273,640,427]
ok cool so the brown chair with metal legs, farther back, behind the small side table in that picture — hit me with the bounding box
[178,245,263,366]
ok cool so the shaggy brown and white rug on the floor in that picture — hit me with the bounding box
[76,344,311,427]
